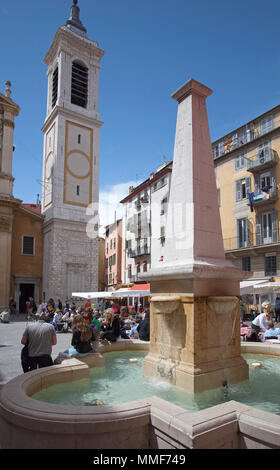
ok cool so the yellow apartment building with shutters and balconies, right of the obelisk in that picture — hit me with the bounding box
[212,105,280,302]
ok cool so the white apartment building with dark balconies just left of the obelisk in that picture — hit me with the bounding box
[121,162,172,284]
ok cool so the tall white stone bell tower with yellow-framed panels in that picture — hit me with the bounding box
[42,0,104,300]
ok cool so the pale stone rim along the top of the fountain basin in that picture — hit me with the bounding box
[0,340,280,426]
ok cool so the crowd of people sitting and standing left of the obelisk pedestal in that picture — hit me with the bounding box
[21,297,150,372]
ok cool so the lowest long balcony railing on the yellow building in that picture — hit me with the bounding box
[224,227,279,251]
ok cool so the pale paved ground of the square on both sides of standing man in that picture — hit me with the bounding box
[0,314,72,388]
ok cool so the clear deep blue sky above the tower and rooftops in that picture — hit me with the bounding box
[0,0,280,227]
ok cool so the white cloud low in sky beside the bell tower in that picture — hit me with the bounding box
[99,181,139,236]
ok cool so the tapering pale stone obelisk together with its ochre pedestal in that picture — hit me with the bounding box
[143,79,250,393]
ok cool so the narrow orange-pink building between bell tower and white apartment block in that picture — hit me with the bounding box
[103,219,122,291]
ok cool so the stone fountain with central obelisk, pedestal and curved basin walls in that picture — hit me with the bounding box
[0,79,280,450]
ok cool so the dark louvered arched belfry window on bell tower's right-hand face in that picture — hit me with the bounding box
[71,61,88,108]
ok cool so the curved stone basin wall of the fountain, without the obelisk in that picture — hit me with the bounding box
[0,340,280,449]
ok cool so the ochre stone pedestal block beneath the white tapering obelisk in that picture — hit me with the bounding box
[143,295,248,393]
